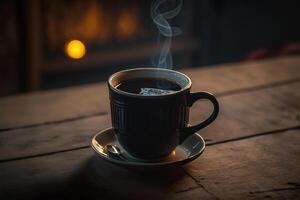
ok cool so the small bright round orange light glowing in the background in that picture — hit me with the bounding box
[65,40,86,59]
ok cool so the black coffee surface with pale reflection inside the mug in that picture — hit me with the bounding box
[117,78,181,95]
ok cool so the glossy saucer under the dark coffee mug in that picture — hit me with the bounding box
[91,128,205,170]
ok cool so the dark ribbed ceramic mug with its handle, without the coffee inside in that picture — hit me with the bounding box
[108,68,219,160]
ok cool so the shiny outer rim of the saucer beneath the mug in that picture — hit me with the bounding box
[91,127,206,167]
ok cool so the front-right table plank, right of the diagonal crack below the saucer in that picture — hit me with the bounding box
[185,129,300,199]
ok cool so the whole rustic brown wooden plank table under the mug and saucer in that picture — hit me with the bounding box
[0,56,300,200]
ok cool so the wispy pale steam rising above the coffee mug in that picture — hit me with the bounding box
[151,0,182,69]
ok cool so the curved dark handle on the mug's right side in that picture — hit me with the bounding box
[180,92,219,143]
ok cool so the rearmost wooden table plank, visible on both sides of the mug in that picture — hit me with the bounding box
[0,56,300,130]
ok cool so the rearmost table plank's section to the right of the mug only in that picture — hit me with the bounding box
[184,56,300,94]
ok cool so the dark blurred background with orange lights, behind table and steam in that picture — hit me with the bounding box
[0,0,300,96]
